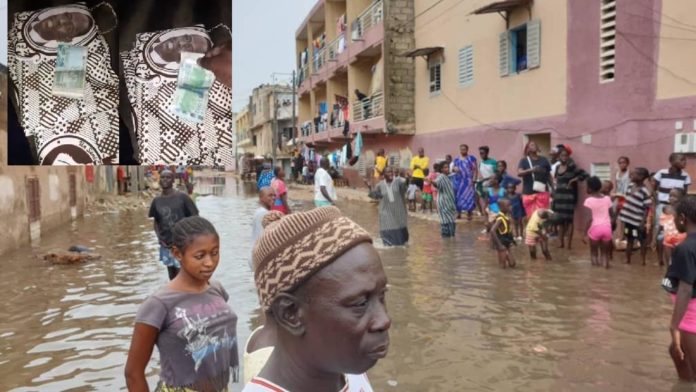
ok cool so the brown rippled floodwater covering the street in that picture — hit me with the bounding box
[0,178,692,391]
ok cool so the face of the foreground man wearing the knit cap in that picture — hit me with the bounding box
[298,243,391,374]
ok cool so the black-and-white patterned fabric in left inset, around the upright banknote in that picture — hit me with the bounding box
[8,4,119,165]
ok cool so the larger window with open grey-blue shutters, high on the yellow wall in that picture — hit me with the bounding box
[498,20,541,76]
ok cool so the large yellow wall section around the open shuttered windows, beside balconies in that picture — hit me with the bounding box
[415,0,564,133]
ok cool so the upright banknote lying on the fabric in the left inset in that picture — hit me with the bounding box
[53,44,87,98]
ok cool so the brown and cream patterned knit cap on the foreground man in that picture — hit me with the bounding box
[253,207,372,311]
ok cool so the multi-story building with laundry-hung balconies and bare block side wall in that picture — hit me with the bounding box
[295,0,415,185]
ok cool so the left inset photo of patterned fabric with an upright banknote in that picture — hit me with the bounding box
[7,1,119,165]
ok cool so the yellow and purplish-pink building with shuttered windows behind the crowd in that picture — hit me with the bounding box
[409,0,696,178]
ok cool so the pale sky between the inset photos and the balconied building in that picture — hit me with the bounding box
[232,0,317,112]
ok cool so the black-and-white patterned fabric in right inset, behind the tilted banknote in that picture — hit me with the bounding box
[121,26,234,166]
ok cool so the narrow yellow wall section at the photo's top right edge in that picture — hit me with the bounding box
[657,0,696,99]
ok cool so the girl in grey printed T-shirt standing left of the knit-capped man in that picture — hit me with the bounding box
[125,216,239,392]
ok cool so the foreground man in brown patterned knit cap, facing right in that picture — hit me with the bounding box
[244,207,391,392]
